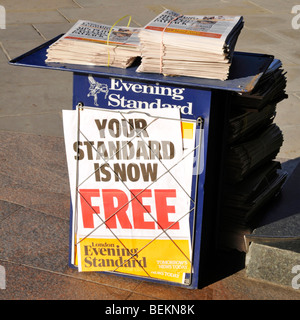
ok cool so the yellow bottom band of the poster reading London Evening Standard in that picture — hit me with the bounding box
[80,238,191,283]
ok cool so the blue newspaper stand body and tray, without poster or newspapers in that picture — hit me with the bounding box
[10,37,273,289]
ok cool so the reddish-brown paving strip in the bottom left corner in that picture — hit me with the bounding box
[0,259,132,301]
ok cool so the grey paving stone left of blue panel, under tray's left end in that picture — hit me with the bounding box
[0,58,72,136]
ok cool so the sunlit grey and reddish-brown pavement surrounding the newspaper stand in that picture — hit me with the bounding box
[0,0,300,300]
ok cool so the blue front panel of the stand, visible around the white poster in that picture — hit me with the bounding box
[71,72,212,288]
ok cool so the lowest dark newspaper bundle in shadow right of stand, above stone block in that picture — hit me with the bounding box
[220,161,287,251]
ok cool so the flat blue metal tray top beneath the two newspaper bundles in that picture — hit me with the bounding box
[9,35,274,92]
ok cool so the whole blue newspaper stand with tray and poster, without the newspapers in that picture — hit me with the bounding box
[10,34,273,288]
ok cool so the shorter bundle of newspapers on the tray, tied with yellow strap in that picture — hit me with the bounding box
[46,20,140,68]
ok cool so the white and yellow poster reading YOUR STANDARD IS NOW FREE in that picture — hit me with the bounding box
[63,107,196,283]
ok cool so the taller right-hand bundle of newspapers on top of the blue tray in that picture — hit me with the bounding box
[137,10,243,80]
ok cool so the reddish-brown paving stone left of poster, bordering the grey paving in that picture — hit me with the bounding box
[0,132,70,215]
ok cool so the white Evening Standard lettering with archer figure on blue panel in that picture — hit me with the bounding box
[87,75,193,115]
